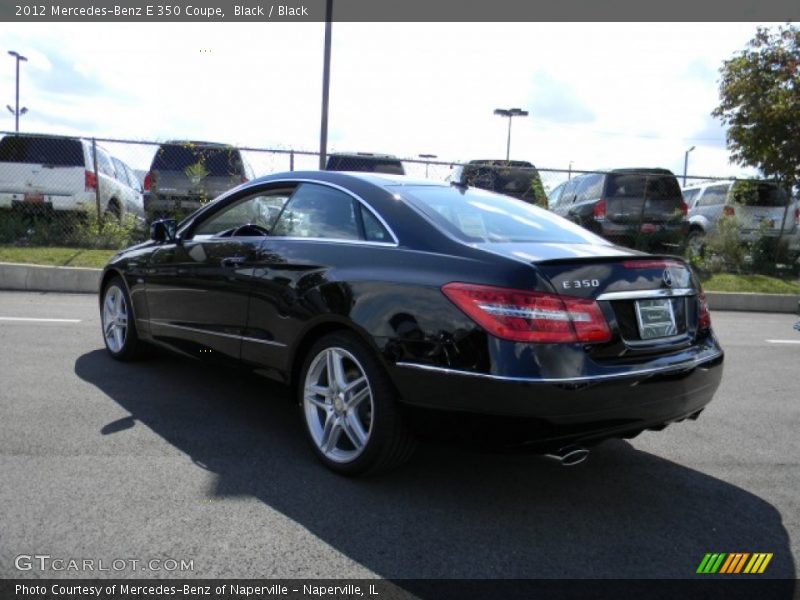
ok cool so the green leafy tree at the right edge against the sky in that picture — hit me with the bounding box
[711,24,800,186]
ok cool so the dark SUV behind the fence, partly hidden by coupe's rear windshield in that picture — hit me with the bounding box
[451,159,547,207]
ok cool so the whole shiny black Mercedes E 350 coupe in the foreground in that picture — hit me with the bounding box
[100,171,723,475]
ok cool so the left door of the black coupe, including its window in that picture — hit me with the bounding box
[145,191,289,361]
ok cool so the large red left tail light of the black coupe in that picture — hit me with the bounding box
[442,283,611,343]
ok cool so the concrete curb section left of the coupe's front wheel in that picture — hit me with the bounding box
[0,263,102,294]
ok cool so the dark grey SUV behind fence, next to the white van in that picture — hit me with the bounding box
[144,140,254,218]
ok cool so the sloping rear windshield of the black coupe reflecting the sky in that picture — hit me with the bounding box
[398,186,608,245]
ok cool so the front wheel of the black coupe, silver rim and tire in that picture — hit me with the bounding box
[100,277,145,361]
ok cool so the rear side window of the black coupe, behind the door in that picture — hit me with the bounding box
[272,183,361,240]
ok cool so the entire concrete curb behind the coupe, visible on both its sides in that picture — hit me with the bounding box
[0,263,800,314]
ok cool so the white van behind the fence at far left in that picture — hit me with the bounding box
[0,133,142,219]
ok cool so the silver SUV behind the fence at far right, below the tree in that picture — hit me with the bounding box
[683,180,800,256]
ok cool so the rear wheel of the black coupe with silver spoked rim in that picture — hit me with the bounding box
[298,332,416,476]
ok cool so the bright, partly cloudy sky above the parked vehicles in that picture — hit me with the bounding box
[0,23,776,183]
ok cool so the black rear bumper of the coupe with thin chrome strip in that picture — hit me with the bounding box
[391,348,724,431]
